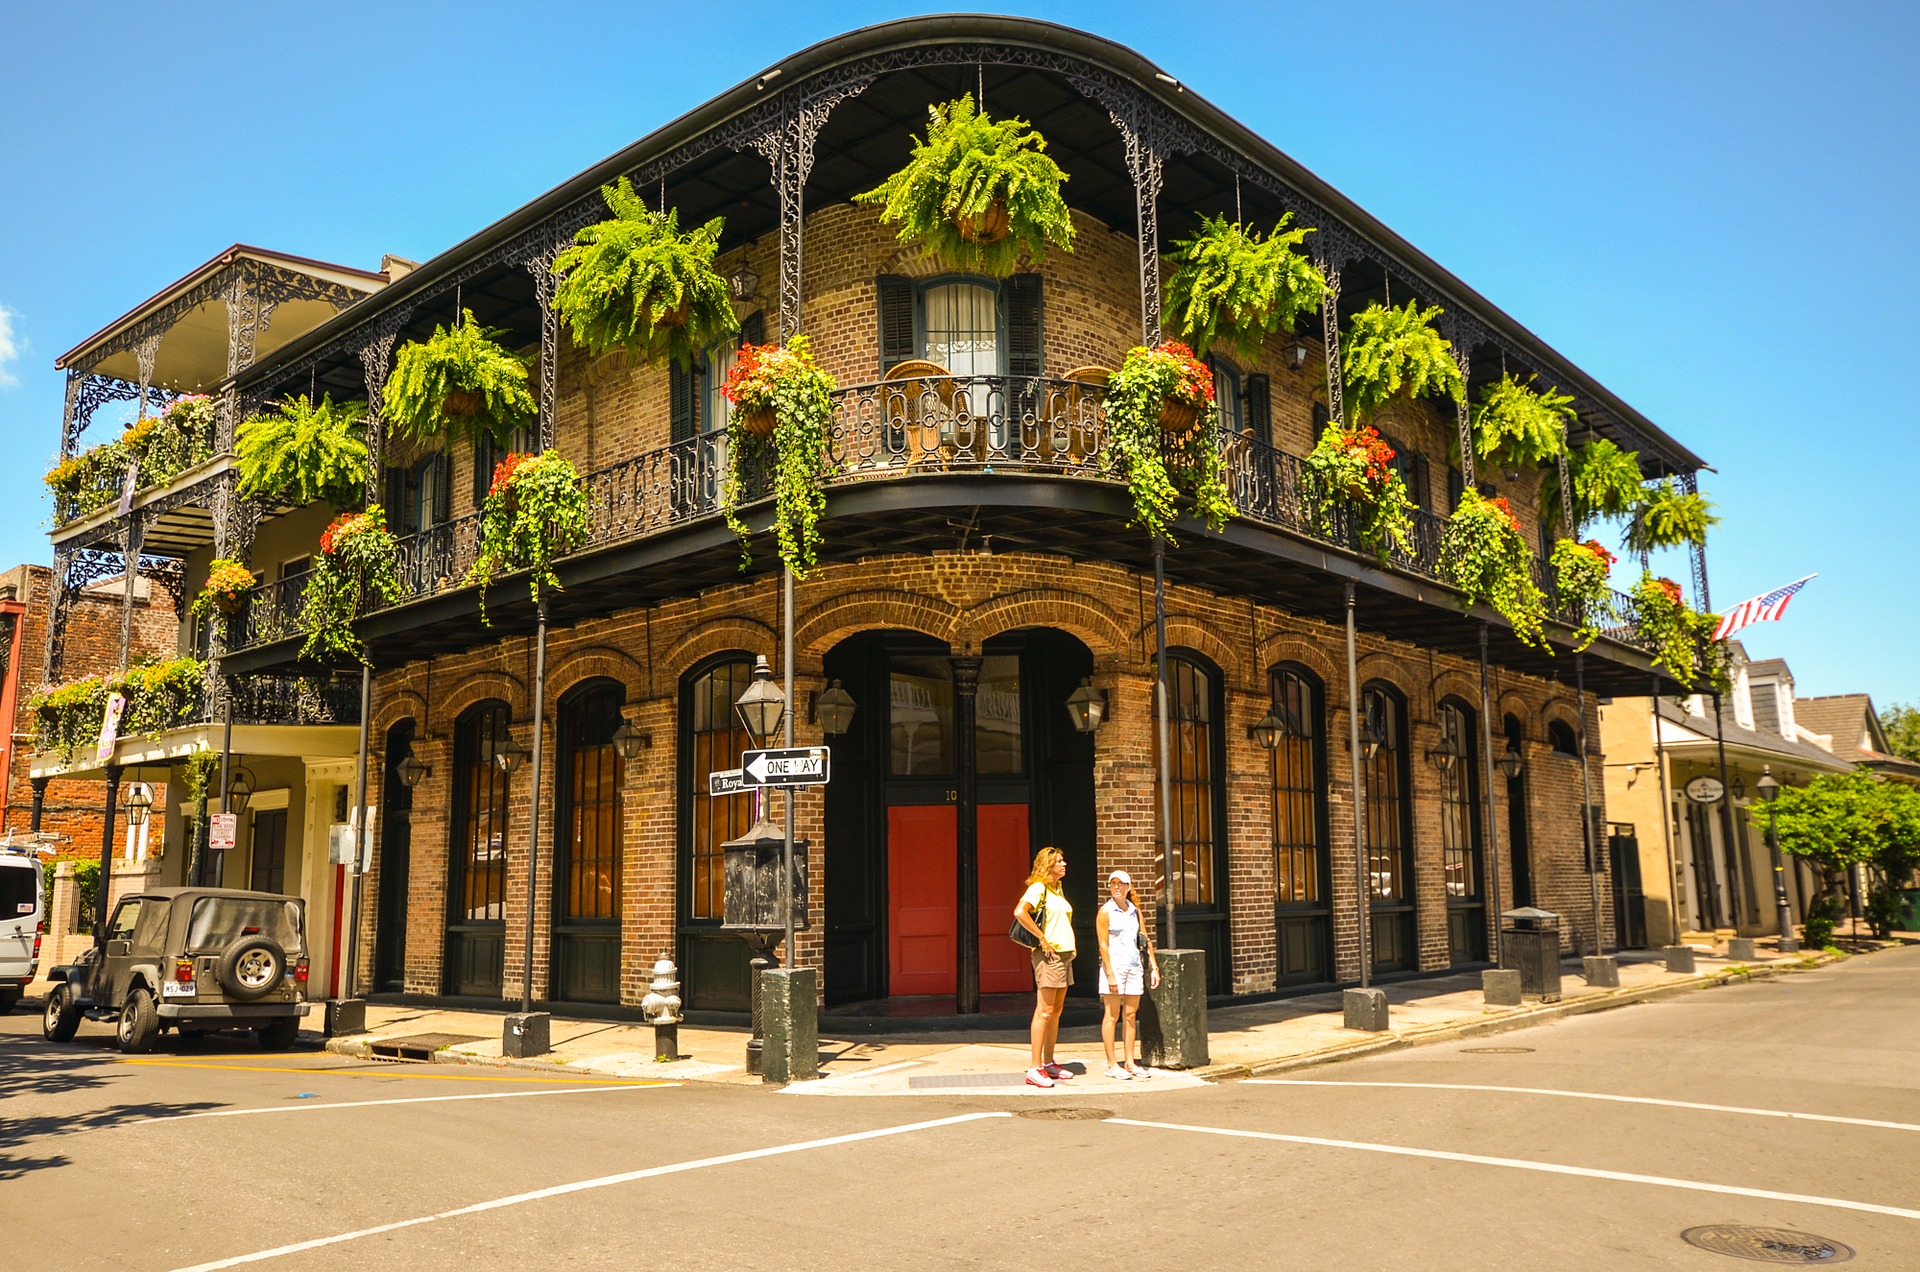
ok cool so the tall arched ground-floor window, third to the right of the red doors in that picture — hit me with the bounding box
[1361,684,1419,972]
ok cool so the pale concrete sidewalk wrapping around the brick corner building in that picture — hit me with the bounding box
[326,942,1901,1097]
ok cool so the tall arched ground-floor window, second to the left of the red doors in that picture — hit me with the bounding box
[553,680,626,1003]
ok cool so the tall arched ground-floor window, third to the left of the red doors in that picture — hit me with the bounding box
[445,699,511,995]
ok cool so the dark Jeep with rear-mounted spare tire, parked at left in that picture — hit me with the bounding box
[42,888,307,1053]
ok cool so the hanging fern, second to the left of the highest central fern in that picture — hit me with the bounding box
[380,309,540,444]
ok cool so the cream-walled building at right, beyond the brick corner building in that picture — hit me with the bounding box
[1599,640,1853,945]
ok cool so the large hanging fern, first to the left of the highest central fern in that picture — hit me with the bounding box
[553,177,739,367]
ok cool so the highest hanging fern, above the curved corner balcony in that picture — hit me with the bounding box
[854,92,1073,279]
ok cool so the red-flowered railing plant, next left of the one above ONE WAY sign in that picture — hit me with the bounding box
[467,450,593,626]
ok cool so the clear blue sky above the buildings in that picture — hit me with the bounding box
[0,0,1920,705]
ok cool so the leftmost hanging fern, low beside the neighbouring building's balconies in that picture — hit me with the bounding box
[234,394,367,511]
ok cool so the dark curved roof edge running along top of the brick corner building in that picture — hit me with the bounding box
[238,13,1707,471]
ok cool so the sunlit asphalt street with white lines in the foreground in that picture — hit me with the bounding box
[0,947,1920,1272]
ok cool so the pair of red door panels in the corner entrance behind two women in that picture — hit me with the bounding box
[887,803,1033,995]
